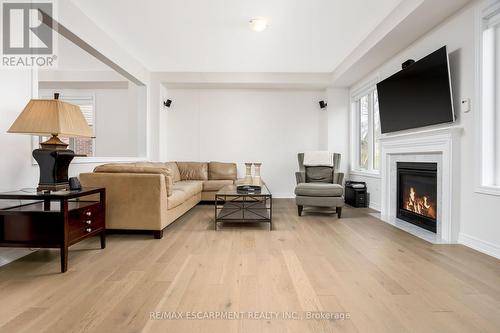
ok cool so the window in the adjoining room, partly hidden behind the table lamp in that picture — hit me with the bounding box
[39,95,95,156]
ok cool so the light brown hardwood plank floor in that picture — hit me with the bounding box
[0,200,500,333]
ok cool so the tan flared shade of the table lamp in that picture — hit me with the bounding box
[7,99,93,138]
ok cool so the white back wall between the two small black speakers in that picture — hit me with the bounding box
[162,89,327,197]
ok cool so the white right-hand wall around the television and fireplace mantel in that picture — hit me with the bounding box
[351,1,500,257]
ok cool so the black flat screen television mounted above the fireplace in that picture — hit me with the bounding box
[377,46,455,133]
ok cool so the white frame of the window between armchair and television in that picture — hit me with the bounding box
[350,79,380,178]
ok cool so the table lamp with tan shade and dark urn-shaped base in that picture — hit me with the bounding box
[7,93,93,191]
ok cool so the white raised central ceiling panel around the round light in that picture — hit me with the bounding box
[72,0,401,72]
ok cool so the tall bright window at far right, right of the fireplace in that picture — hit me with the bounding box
[477,0,500,194]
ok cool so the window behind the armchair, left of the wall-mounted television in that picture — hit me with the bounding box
[352,88,381,172]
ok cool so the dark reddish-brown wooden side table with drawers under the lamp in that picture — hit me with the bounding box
[0,188,106,272]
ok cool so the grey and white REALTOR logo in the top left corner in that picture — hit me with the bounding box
[2,2,57,67]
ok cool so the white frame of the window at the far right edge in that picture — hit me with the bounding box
[475,0,500,196]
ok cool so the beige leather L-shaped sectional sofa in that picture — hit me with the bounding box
[80,162,237,238]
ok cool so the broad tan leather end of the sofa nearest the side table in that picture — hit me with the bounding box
[80,172,168,230]
